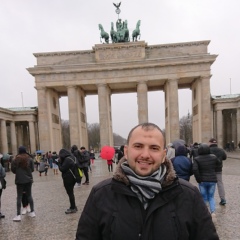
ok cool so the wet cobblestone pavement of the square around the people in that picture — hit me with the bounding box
[0,152,240,240]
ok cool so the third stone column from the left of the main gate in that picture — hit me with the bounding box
[98,84,113,147]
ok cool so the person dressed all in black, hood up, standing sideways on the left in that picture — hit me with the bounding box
[58,149,78,214]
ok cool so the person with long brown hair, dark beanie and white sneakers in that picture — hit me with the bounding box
[11,146,36,222]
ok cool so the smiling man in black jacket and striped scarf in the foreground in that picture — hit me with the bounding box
[76,123,219,240]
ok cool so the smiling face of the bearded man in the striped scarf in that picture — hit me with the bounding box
[124,127,166,176]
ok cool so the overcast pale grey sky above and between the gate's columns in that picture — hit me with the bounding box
[0,0,240,137]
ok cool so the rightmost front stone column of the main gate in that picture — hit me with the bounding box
[199,76,213,143]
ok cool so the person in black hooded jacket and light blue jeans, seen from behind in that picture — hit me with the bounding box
[193,143,219,217]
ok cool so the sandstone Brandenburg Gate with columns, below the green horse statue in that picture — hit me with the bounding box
[27,41,217,151]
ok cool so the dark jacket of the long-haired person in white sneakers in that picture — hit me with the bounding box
[11,153,34,184]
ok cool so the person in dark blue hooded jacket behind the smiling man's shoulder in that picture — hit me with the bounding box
[171,143,193,181]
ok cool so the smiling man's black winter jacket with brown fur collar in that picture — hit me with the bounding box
[76,158,219,240]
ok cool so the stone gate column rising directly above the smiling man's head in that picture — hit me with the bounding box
[137,81,148,124]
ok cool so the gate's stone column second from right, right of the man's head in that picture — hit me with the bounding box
[164,79,180,143]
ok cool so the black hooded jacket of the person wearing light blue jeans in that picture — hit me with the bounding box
[193,143,219,183]
